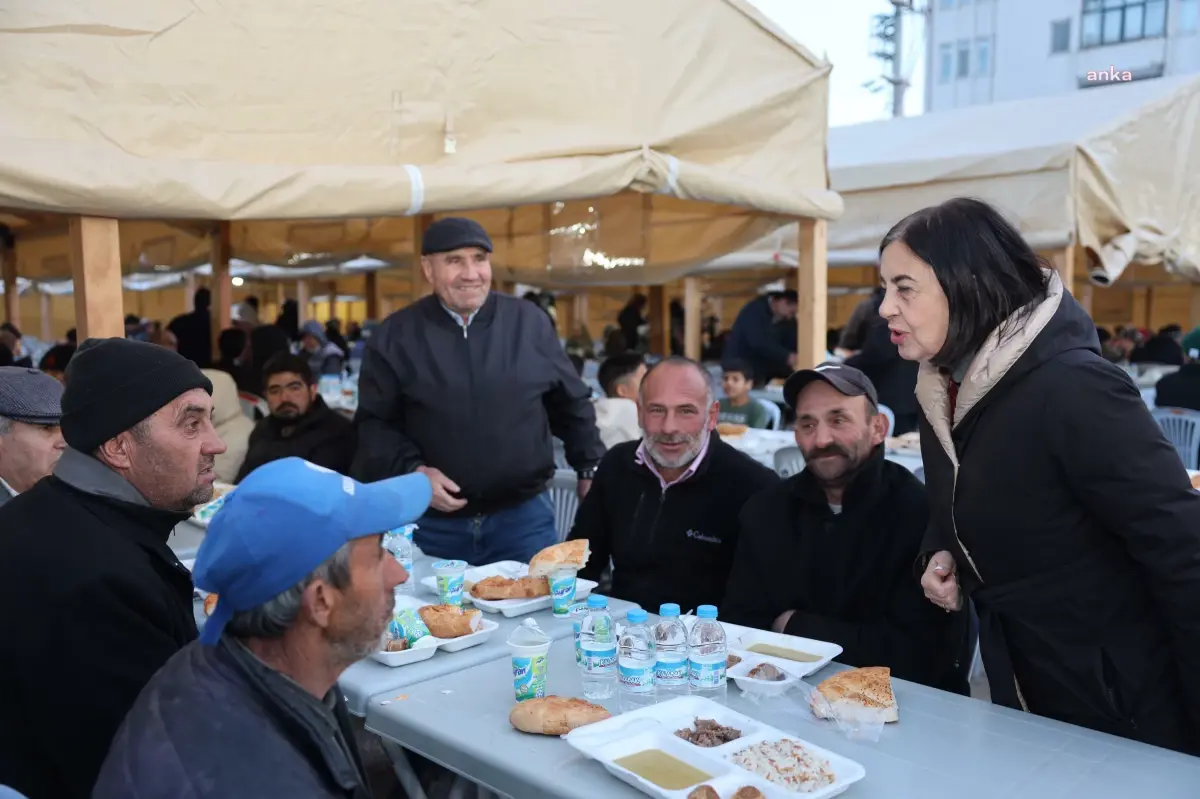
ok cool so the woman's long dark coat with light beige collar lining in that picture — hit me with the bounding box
[917,276,1200,753]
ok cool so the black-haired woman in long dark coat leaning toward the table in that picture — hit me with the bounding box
[880,199,1200,753]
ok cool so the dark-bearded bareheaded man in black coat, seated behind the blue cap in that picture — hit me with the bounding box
[238,353,356,482]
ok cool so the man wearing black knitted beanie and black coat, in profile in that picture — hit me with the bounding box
[0,338,224,799]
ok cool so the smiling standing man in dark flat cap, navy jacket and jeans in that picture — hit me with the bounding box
[354,218,605,564]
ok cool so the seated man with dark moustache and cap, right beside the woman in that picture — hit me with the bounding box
[722,364,966,693]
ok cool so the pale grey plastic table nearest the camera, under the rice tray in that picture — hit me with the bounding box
[366,638,1200,799]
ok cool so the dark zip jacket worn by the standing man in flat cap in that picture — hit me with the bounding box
[353,292,605,516]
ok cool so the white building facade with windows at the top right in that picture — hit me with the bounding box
[925,0,1200,112]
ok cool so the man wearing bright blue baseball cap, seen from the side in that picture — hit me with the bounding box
[92,458,432,799]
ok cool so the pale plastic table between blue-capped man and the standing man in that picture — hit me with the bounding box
[337,593,637,716]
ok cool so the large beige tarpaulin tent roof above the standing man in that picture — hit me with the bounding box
[0,0,841,283]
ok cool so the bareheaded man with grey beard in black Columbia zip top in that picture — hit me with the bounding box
[570,358,779,611]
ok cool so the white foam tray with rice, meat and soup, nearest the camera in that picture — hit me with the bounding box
[565,696,866,799]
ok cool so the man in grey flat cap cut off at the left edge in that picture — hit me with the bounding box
[0,366,64,506]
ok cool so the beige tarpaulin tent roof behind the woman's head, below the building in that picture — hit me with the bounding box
[702,76,1200,283]
